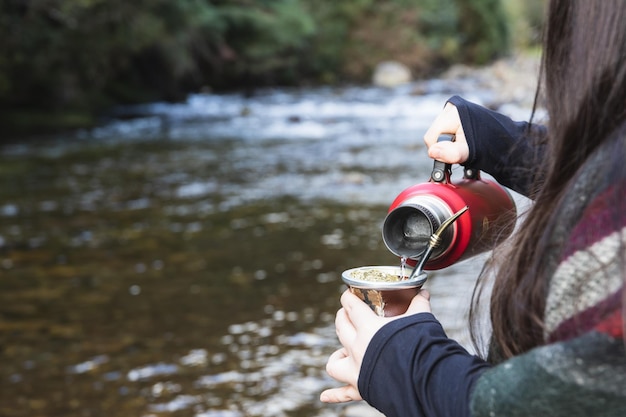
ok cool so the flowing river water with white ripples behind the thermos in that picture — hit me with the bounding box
[0,76,528,417]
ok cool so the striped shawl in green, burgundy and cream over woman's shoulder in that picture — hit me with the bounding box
[471,128,626,417]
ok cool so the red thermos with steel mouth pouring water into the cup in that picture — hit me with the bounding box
[383,135,517,270]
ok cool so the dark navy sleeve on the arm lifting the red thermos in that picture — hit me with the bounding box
[448,96,547,196]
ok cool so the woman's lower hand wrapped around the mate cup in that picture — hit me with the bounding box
[320,290,430,403]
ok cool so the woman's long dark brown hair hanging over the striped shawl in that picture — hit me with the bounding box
[470,0,626,360]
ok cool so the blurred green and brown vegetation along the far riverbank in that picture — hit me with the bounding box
[0,0,545,133]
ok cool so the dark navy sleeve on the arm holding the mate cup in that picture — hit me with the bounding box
[358,313,490,417]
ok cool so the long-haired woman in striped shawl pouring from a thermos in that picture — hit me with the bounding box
[321,0,626,417]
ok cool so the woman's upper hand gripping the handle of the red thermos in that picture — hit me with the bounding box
[424,102,469,164]
